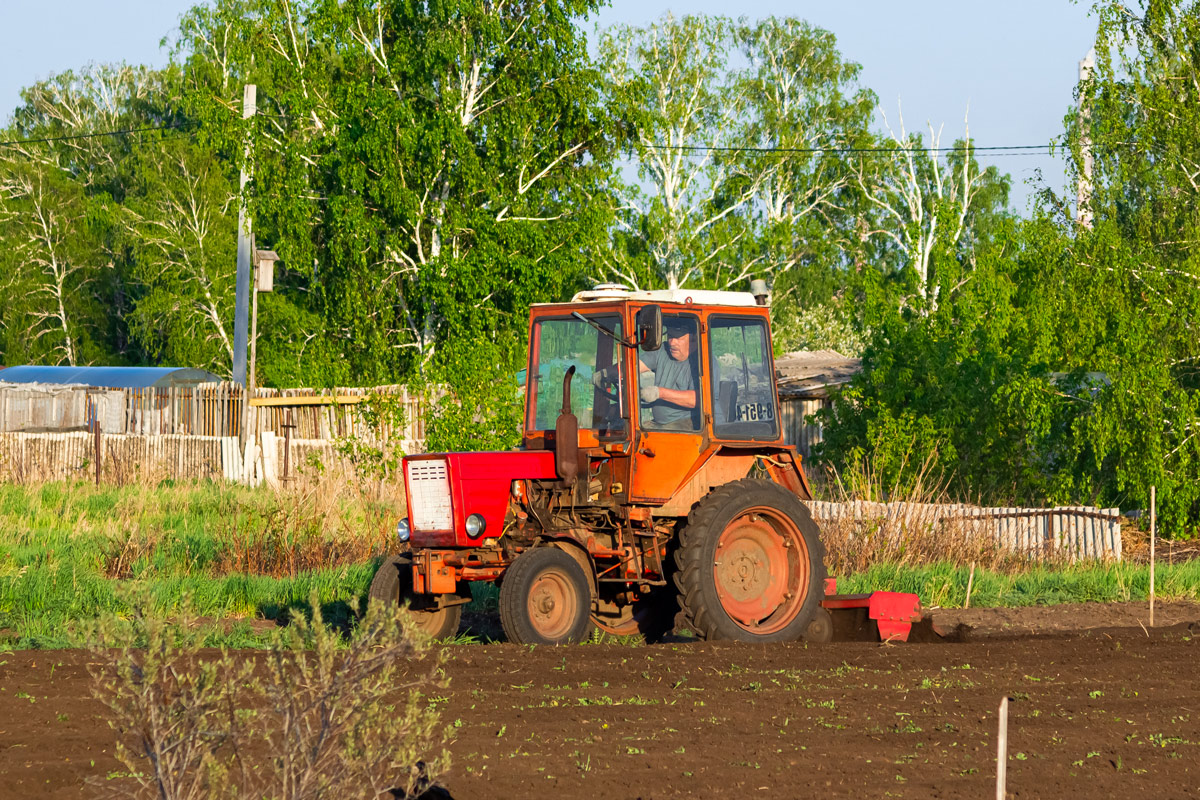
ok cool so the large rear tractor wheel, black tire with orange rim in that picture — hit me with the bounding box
[674,479,826,642]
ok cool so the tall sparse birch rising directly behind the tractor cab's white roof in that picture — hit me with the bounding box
[599,14,757,289]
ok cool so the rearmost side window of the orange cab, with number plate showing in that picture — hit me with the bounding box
[709,317,779,439]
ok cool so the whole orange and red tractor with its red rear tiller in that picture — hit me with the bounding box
[371,285,919,644]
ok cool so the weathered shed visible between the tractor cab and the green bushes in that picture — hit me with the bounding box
[775,350,863,458]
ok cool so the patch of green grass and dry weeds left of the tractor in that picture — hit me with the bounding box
[0,483,384,648]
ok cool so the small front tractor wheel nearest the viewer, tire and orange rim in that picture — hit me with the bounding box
[500,547,592,644]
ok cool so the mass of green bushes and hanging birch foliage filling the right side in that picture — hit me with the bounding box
[824,2,1200,535]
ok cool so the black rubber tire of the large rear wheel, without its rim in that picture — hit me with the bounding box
[674,477,826,642]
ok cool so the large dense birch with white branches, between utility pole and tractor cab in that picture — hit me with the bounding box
[182,0,606,381]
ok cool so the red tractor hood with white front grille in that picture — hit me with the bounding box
[403,450,558,547]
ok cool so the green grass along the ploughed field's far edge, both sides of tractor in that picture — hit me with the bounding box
[0,483,1200,648]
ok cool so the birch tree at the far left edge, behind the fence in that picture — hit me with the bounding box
[0,65,152,365]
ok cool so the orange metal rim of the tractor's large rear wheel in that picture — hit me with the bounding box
[713,506,811,634]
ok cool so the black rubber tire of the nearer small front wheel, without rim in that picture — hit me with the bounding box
[499,547,593,644]
